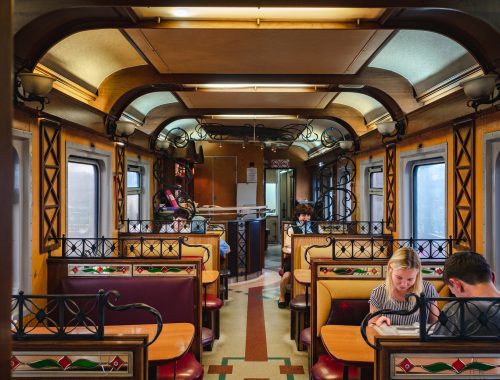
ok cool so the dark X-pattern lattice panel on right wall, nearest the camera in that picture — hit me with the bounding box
[453,119,475,250]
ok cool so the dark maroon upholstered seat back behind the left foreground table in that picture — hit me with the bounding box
[61,277,195,325]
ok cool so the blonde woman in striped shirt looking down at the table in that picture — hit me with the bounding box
[369,248,439,326]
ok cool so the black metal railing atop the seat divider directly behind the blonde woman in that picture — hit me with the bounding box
[304,236,457,264]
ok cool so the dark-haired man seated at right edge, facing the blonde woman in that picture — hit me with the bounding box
[432,252,500,336]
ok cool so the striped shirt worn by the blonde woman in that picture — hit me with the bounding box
[368,281,438,325]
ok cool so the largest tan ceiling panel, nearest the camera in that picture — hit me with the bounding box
[127,29,391,74]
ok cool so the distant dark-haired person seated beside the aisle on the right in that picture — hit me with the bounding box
[278,204,322,309]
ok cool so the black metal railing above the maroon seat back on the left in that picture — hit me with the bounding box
[49,235,210,263]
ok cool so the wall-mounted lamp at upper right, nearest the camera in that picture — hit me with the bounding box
[460,74,500,112]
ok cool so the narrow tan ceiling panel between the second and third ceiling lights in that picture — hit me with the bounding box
[177,91,333,109]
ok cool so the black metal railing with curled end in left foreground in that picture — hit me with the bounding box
[10,290,163,346]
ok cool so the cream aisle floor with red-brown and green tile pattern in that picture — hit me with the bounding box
[202,271,308,380]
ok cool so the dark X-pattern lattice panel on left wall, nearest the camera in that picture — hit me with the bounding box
[40,119,61,252]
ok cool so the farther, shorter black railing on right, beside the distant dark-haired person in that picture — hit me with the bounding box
[283,220,387,236]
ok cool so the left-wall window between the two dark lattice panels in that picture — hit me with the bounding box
[67,156,100,238]
